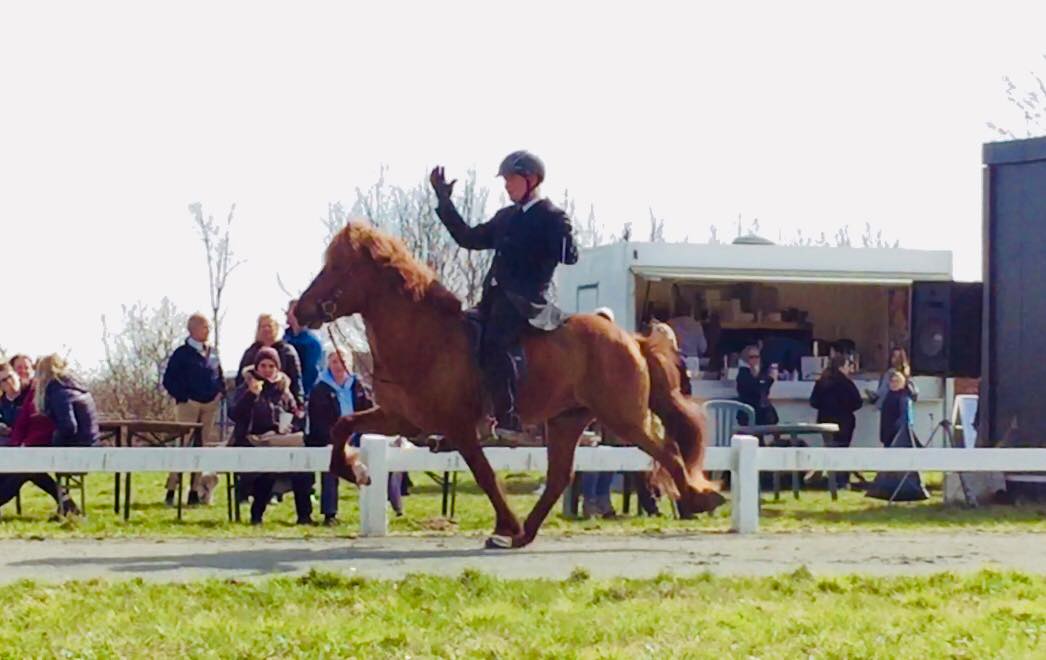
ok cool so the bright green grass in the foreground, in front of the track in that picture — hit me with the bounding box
[0,569,1046,658]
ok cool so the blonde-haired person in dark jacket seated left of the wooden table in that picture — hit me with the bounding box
[33,354,98,447]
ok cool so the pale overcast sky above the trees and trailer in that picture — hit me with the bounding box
[0,1,1046,365]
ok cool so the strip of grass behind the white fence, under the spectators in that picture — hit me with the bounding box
[0,466,1046,538]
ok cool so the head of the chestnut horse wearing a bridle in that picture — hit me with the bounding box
[295,225,374,329]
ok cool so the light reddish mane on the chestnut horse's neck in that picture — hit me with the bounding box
[325,222,461,314]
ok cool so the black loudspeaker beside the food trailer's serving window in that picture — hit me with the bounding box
[910,281,983,378]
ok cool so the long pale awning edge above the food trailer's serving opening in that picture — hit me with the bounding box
[631,266,949,287]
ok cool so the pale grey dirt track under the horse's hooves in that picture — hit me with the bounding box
[0,532,1046,583]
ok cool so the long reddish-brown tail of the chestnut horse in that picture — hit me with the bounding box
[637,337,719,493]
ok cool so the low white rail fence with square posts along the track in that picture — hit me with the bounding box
[0,435,1046,536]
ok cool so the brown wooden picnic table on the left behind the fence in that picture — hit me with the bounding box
[98,419,203,520]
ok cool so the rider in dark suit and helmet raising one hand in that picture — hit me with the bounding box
[429,151,577,439]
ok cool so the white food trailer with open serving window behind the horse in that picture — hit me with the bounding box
[556,236,953,447]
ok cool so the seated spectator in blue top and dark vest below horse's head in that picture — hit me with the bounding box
[305,350,376,526]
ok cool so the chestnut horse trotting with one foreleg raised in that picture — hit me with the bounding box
[295,223,723,547]
